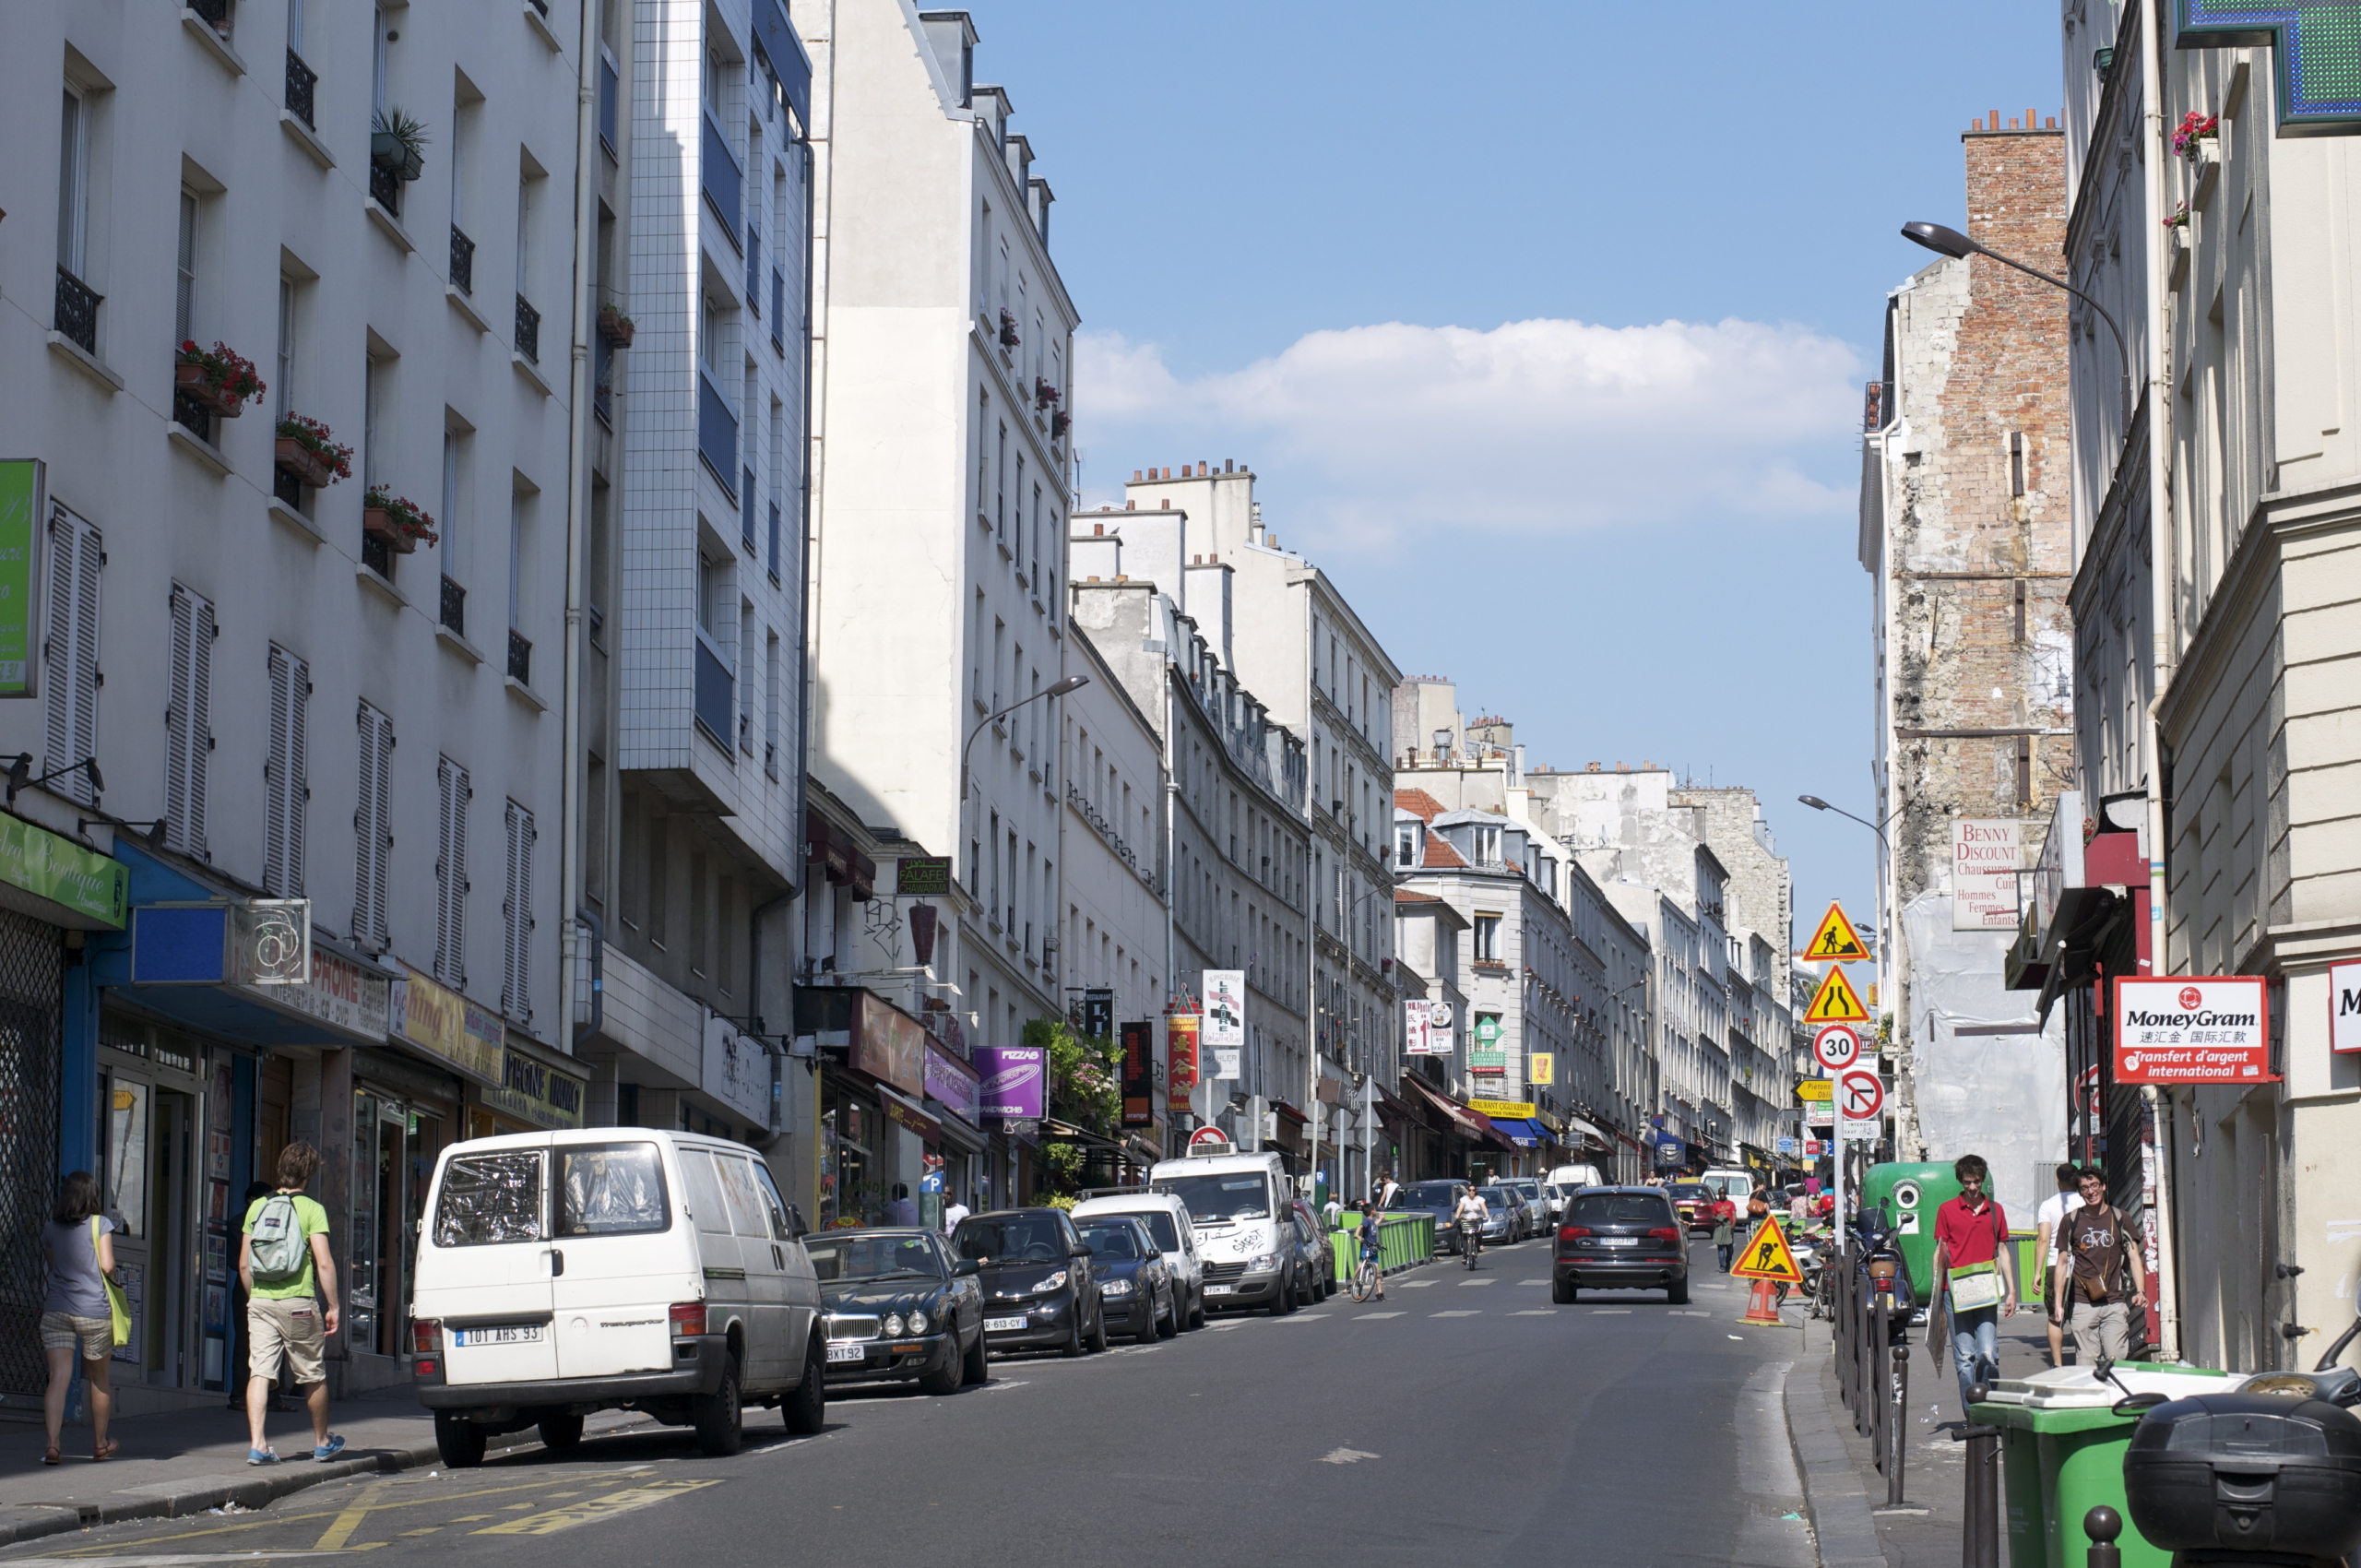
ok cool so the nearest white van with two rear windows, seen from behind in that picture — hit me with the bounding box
[410,1126,826,1468]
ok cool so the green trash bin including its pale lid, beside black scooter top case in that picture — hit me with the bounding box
[1969,1360,2236,1568]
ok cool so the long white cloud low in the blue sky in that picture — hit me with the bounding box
[1074,319,1860,545]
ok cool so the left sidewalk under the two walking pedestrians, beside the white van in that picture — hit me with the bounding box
[0,1388,647,1544]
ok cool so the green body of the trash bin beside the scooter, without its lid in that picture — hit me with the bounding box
[1969,1405,2172,1568]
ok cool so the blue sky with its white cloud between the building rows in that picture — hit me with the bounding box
[973,0,2061,968]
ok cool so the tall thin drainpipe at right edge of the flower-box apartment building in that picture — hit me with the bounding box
[557,0,607,1067]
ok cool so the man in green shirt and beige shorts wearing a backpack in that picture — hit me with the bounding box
[239,1143,345,1464]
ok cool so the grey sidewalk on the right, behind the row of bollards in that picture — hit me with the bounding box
[1787,1313,2070,1568]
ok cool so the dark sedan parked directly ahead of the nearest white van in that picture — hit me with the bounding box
[802,1228,990,1394]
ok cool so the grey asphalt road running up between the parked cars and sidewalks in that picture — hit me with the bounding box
[0,1242,1813,1568]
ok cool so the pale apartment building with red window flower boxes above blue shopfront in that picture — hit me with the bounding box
[0,0,587,1415]
